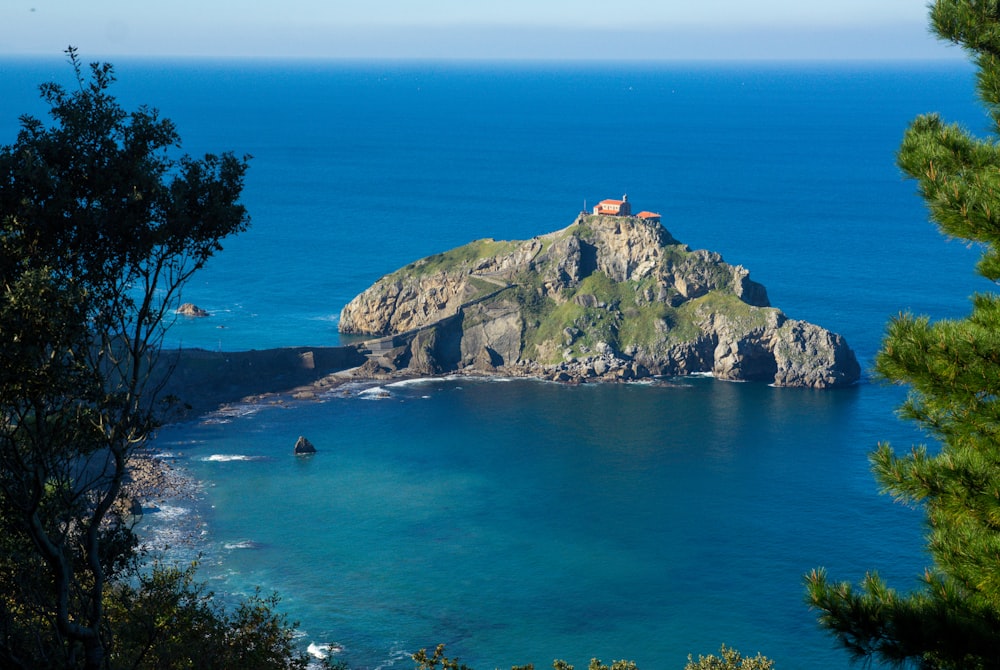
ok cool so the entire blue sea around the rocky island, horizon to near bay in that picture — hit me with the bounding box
[0,58,991,670]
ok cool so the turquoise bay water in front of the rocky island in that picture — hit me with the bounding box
[152,379,924,668]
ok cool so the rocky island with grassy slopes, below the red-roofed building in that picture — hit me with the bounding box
[340,214,860,388]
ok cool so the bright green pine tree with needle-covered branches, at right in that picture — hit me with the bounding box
[806,0,1000,668]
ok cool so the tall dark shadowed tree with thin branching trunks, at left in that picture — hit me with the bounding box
[0,49,262,670]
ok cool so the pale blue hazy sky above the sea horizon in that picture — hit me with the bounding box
[0,0,962,59]
